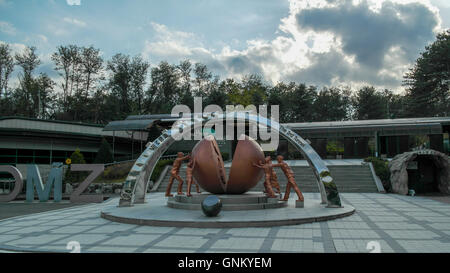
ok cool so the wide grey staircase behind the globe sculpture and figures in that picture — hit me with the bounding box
[156,165,378,192]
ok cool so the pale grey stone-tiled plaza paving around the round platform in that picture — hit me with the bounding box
[0,193,450,253]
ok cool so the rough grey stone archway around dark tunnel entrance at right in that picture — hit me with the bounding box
[388,149,450,195]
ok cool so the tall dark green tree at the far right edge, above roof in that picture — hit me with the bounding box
[404,30,450,117]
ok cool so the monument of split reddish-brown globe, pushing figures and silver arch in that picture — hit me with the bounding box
[119,112,341,207]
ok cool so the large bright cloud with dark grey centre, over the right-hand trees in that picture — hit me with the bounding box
[144,0,440,90]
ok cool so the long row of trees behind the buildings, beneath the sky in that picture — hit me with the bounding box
[0,30,450,124]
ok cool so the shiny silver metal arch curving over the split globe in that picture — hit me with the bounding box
[119,112,341,207]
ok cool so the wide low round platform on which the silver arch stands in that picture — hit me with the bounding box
[101,193,355,228]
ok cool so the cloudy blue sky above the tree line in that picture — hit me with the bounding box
[0,0,450,92]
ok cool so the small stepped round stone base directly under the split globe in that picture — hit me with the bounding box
[167,192,287,211]
